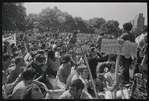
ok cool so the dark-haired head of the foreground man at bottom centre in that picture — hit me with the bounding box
[69,79,84,97]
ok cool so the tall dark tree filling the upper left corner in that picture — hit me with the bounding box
[2,3,26,31]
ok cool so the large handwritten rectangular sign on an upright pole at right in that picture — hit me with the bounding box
[100,39,137,58]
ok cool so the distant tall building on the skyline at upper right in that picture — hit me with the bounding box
[130,13,145,29]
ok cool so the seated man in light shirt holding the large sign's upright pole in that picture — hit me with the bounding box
[104,61,129,99]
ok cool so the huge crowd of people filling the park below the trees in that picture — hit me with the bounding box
[2,23,148,99]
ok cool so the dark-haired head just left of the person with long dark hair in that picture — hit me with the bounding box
[35,54,46,66]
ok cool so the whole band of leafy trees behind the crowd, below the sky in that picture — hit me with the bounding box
[2,3,121,36]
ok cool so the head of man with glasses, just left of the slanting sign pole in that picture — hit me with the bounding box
[76,65,89,79]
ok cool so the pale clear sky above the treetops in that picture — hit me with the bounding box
[24,2,147,28]
